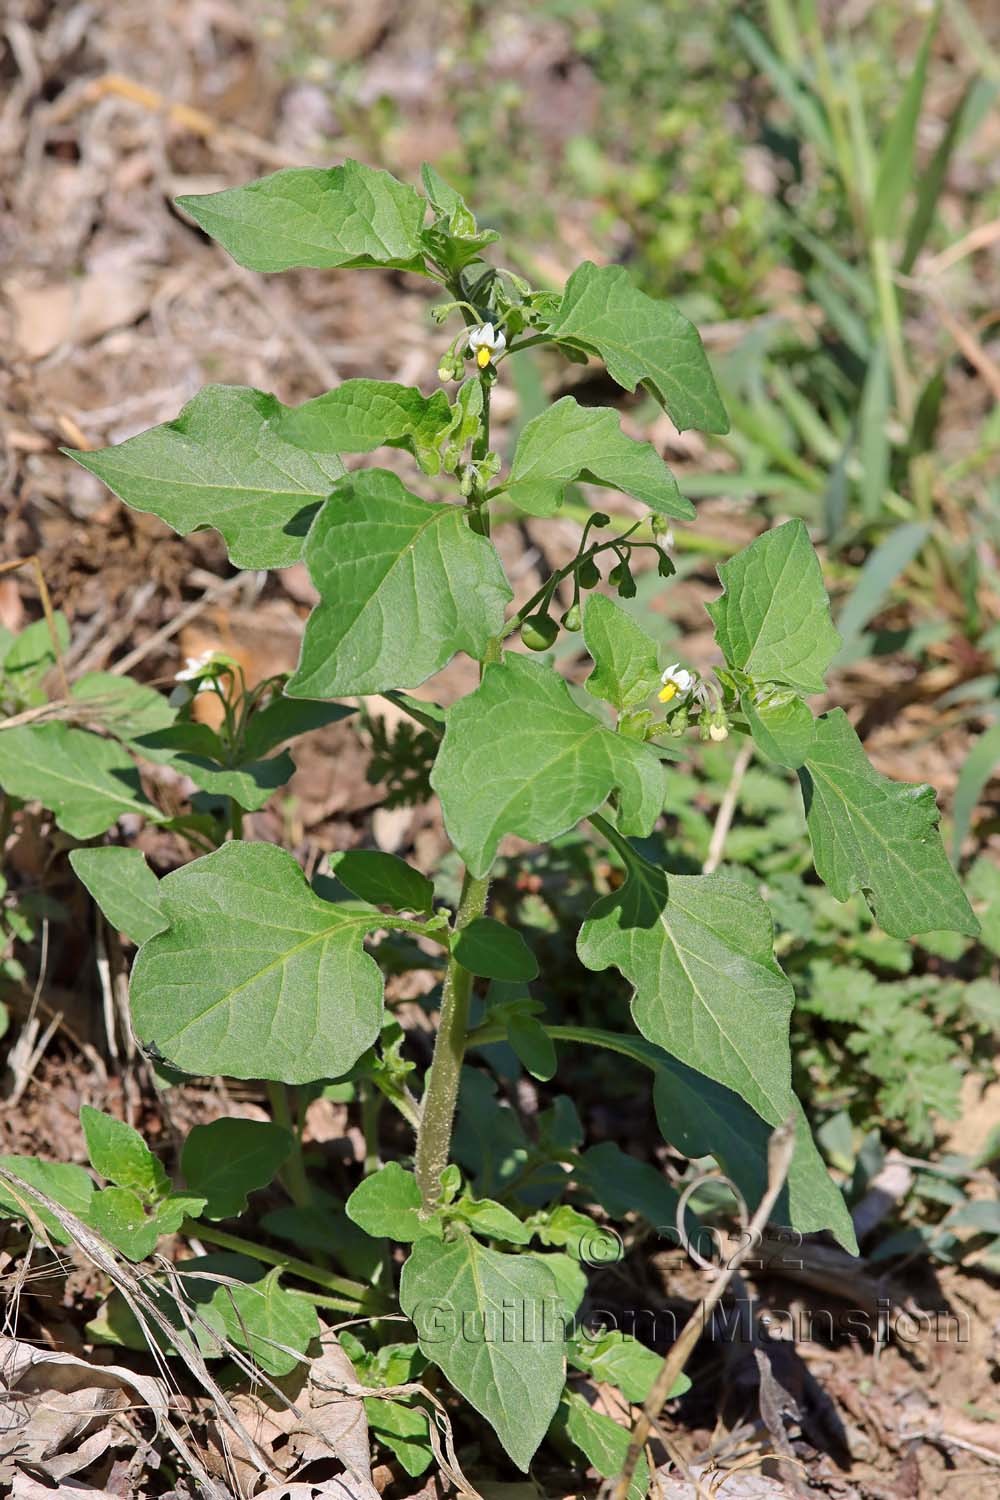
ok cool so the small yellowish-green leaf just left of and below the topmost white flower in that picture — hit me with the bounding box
[277,380,451,474]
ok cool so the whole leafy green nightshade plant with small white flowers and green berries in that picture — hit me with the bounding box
[0,162,976,1473]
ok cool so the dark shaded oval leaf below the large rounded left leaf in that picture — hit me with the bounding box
[180,1116,294,1220]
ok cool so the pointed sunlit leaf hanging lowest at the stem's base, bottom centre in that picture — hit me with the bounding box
[399,1235,565,1472]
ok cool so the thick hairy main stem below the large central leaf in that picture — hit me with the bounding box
[414,870,490,1215]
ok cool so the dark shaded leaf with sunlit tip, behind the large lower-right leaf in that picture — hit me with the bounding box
[654,1056,858,1257]
